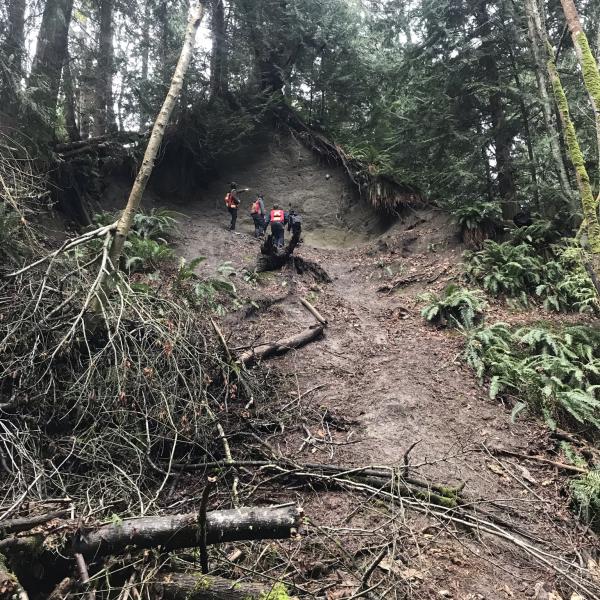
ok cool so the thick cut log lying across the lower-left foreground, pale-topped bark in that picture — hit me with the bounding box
[0,505,303,559]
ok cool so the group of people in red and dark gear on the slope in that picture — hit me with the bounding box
[225,182,302,248]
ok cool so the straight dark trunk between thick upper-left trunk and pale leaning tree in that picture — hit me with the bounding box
[94,0,117,135]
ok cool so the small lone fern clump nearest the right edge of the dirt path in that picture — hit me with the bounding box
[421,284,486,328]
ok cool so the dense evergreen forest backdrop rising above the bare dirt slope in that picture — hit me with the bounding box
[0,0,600,218]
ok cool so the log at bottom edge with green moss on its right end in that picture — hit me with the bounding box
[152,573,289,600]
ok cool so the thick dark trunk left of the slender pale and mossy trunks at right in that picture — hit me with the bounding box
[477,0,517,220]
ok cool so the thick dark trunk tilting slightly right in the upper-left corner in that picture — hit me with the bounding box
[28,0,73,141]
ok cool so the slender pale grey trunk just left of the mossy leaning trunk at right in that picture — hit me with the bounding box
[525,0,579,210]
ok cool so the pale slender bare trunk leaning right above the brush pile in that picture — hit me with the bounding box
[109,2,204,268]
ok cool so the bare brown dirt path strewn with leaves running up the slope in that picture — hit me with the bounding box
[162,195,594,600]
